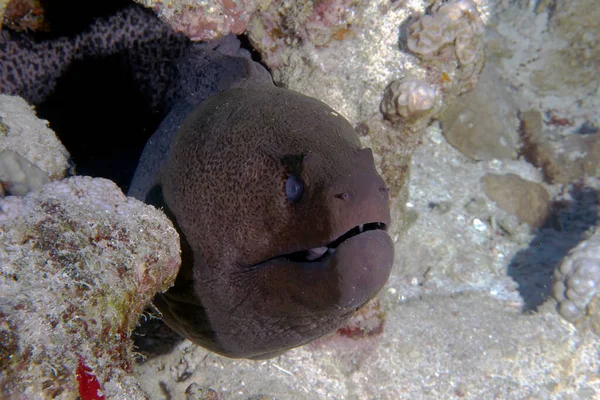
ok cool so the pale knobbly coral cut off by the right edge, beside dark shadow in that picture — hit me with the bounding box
[552,230,600,335]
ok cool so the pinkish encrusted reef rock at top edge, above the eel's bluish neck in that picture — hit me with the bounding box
[136,0,268,41]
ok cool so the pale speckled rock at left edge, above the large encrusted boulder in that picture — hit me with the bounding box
[0,95,69,180]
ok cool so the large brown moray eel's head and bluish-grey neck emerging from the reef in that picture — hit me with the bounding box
[0,3,393,359]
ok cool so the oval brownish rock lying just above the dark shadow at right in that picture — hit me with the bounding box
[481,174,550,229]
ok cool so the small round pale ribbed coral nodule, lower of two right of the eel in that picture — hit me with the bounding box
[381,78,440,122]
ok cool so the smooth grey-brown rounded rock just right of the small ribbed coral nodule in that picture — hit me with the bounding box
[441,66,519,160]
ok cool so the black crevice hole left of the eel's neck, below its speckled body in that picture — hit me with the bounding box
[36,55,163,192]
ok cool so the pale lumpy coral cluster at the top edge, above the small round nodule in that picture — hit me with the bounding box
[407,0,484,65]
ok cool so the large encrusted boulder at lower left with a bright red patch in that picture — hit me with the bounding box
[0,177,180,399]
